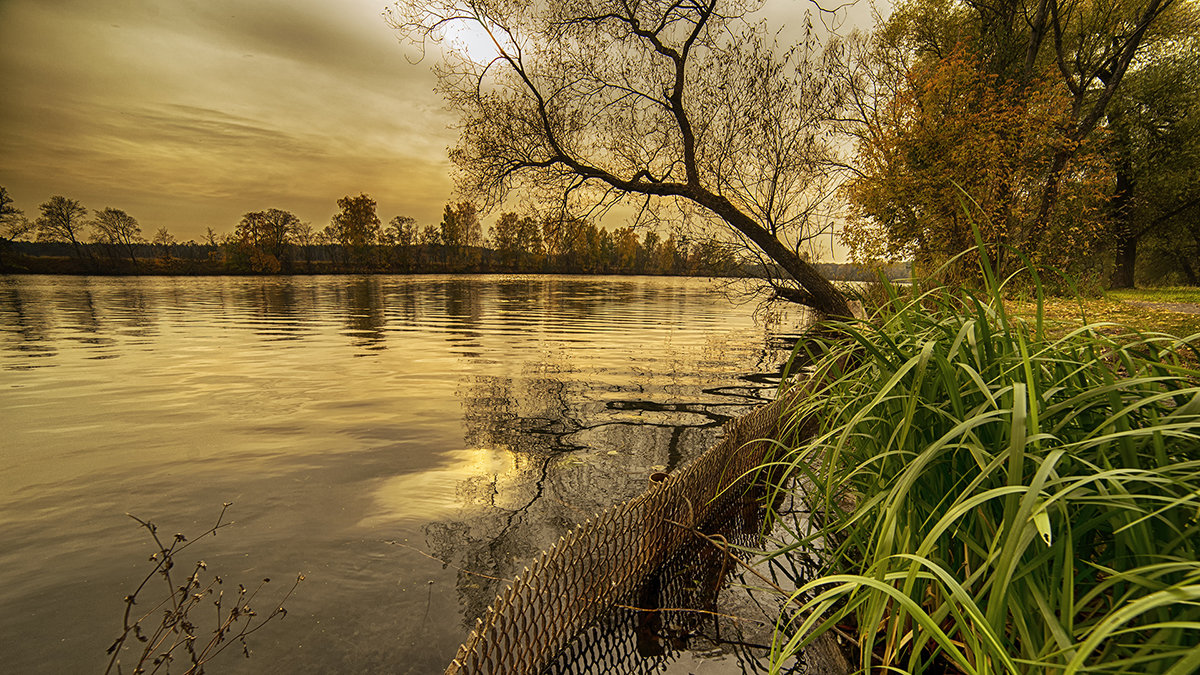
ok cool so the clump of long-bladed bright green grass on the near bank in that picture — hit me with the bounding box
[773,256,1200,675]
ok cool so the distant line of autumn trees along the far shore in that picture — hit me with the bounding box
[0,195,907,280]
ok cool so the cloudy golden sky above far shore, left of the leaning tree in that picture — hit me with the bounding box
[0,0,883,247]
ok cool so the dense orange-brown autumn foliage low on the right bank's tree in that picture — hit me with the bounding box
[844,43,1111,281]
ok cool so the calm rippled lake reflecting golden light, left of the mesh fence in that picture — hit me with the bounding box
[0,271,806,673]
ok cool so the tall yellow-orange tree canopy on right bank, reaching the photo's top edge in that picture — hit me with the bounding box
[834,0,1194,282]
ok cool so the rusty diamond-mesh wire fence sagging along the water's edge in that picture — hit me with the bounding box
[446,398,791,675]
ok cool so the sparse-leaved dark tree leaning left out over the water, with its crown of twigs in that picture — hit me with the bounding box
[385,0,850,316]
